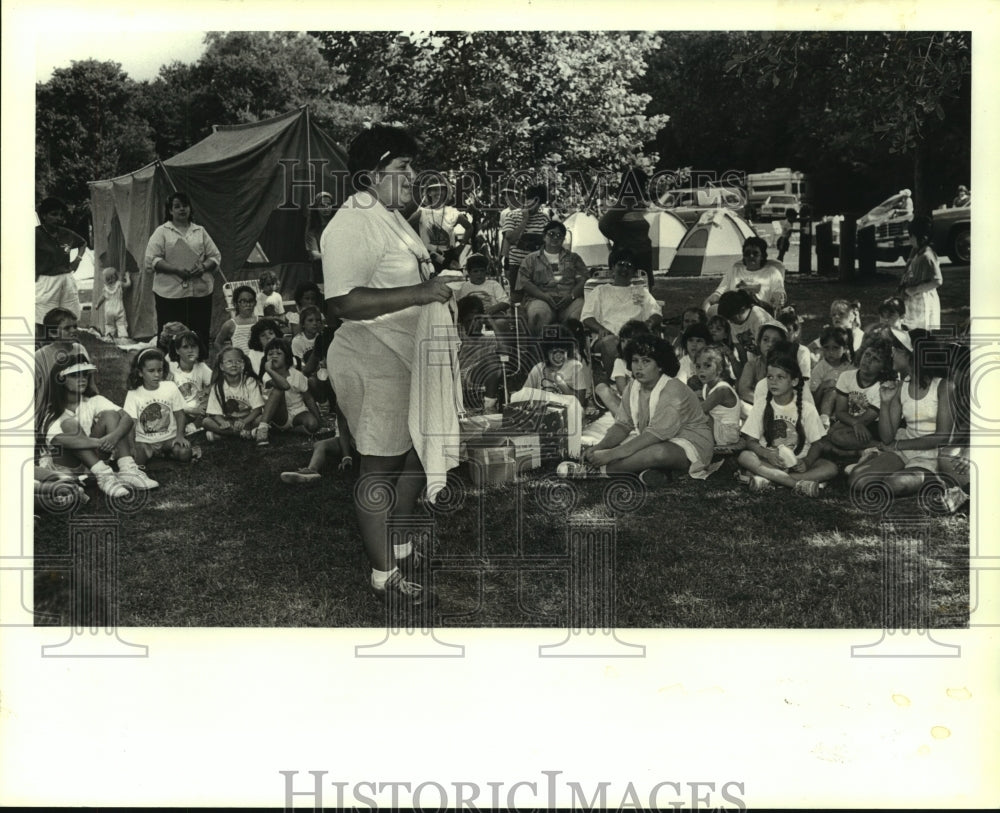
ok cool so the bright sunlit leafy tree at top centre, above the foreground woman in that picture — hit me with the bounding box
[314,31,667,187]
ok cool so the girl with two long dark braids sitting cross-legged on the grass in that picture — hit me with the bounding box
[737,351,837,497]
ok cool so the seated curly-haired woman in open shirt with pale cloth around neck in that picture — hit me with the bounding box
[556,335,714,486]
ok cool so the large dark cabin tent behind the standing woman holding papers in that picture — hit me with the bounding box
[90,107,348,338]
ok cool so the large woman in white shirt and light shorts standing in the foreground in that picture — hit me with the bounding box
[321,124,452,607]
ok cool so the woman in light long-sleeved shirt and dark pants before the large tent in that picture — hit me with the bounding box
[145,192,222,347]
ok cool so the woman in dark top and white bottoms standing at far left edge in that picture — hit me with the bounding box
[35,198,87,342]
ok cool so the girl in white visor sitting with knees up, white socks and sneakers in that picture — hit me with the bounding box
[39,355,150,497]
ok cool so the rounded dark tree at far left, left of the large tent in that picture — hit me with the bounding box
[35,59,154,217]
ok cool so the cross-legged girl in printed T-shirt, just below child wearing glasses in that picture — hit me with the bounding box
[202,347,264,441]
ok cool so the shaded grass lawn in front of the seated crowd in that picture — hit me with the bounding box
[34,265,969,628]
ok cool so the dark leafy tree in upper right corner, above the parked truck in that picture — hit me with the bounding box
[726,31,972,211]
